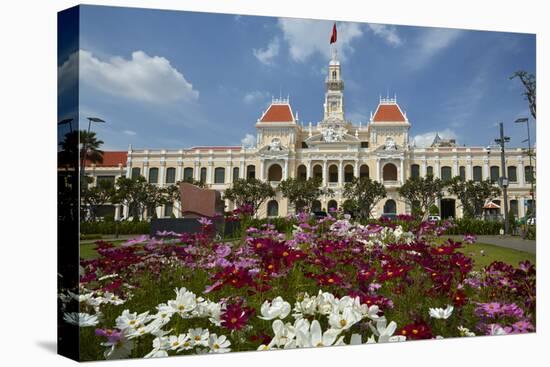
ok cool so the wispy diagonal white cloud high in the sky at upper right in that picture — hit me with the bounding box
[406,28,464,69]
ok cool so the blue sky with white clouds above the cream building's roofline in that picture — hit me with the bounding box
[59,6,536,150]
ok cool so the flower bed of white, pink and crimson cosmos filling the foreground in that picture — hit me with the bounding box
[60,216,535,360]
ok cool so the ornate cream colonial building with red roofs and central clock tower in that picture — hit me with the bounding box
[86,52,532,218]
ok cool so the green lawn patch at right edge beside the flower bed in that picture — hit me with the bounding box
[459,243,535,269]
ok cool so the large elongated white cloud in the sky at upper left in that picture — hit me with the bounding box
[59,50,199,103]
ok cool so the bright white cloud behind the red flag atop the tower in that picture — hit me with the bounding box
[278,18,363,62]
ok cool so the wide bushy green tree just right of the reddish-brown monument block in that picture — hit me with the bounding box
[224,178,275,213]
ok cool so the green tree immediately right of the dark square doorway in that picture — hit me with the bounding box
[449,177,501,218]
